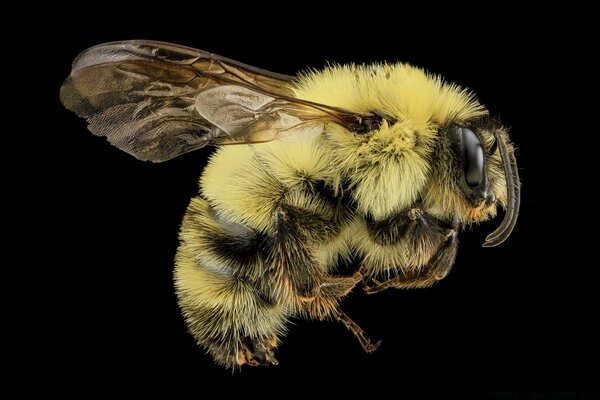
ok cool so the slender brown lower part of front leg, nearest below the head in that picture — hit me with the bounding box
[363,229,458,294]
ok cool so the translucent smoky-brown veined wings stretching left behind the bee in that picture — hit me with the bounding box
[61,41,378,162]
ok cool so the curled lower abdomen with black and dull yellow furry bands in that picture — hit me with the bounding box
[175,197,288,367]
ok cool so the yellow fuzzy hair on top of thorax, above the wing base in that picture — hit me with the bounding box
[295,63,487,128]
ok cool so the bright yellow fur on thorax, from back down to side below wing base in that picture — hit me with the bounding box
[296,64,487,219]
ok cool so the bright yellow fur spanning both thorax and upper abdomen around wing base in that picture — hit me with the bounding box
[201,64,487,223]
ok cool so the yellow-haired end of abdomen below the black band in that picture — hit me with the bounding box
[175,245,287,367]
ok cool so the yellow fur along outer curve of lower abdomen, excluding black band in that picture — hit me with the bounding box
[175,198,288,366]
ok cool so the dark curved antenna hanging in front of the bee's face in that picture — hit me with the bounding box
[483,132,521,247]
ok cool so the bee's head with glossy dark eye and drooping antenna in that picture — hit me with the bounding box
[423,118,520,247]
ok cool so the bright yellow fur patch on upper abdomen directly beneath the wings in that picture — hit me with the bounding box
[200,139,332,231]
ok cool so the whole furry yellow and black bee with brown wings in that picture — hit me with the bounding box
[60,40,520,368]
